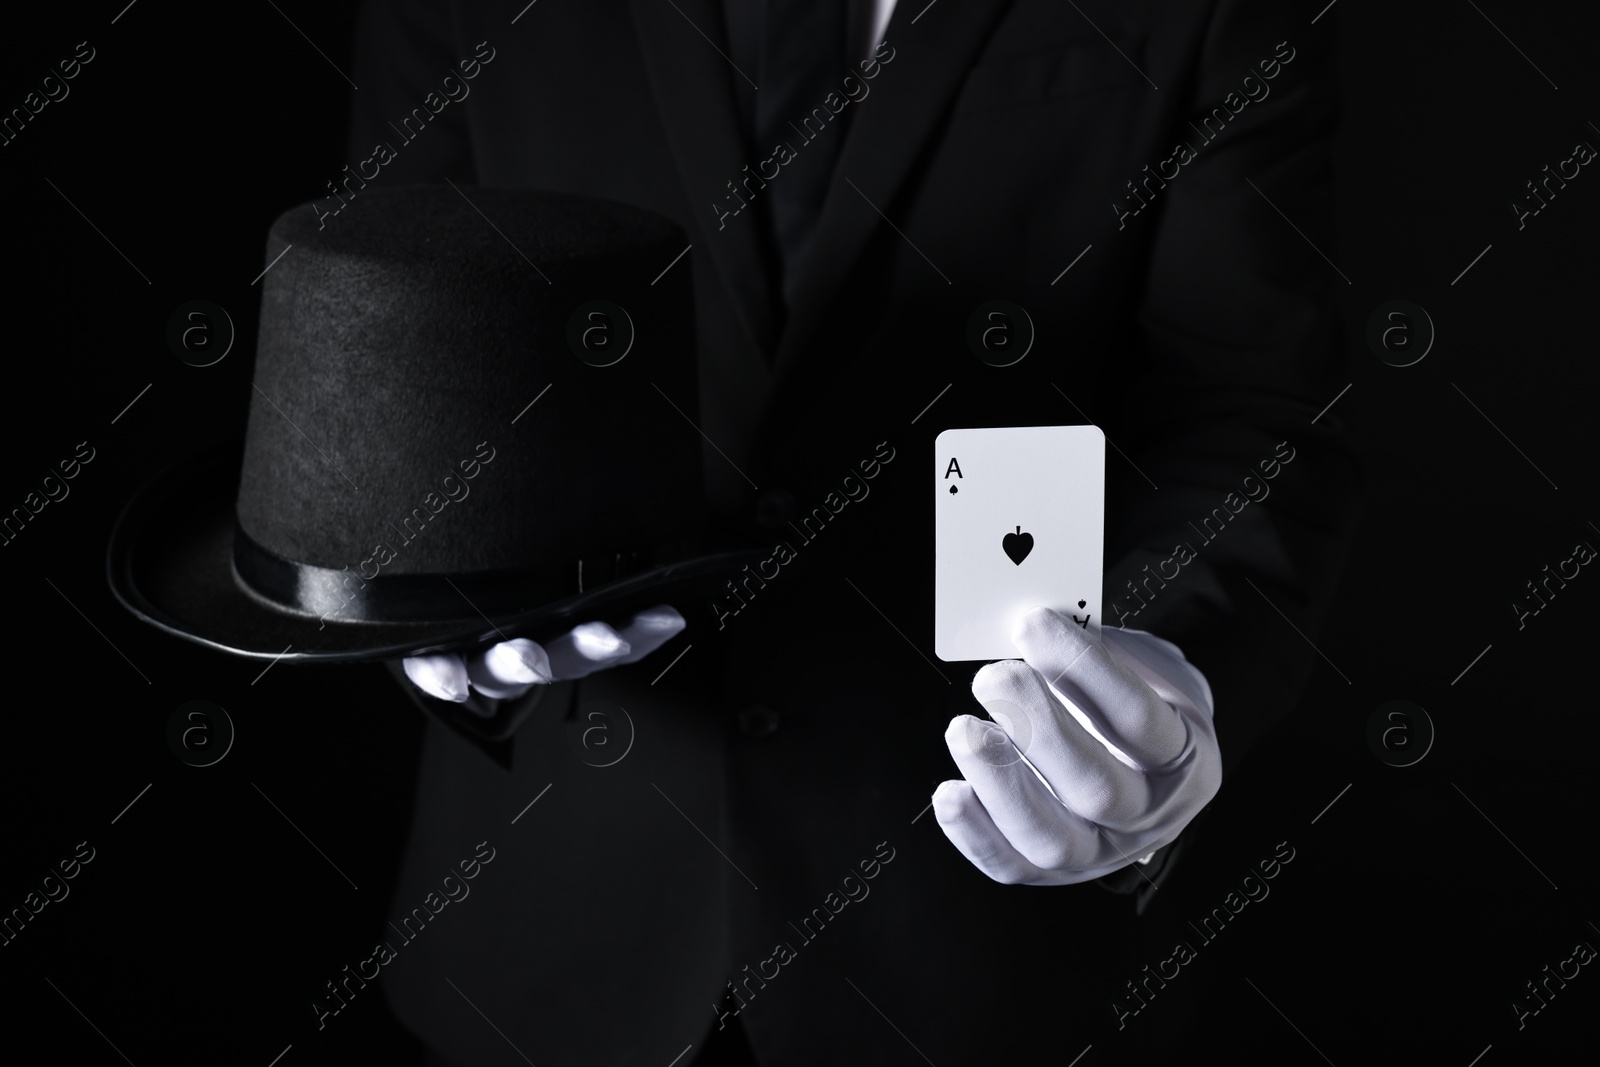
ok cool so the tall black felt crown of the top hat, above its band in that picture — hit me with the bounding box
[237,186,702,591]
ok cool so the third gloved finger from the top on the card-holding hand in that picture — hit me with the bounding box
[944,715,1106,872]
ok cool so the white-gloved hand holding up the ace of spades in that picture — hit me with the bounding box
[933,608,1222,885]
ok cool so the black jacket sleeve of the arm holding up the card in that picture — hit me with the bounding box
[1104,0,1360,776]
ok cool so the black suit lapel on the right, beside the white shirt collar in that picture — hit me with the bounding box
[757,0,1011,463]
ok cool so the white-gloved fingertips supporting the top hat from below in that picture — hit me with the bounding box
[405,605,688,704]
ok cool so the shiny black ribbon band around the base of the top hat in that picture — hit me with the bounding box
[234,522,690,622]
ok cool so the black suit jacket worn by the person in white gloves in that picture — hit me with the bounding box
[340,0,1357,1064]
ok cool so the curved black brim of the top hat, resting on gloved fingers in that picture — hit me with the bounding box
[106,445,762,662]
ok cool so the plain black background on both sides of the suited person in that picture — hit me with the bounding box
[0,0,1600,1065]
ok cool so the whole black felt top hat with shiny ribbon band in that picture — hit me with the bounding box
[107,186,752,661]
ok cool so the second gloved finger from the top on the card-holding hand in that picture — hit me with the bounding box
[968,659,1152,831]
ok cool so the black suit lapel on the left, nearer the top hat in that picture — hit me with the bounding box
[629,0,778,355]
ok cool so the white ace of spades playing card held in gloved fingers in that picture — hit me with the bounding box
[933,426,1106,661]
